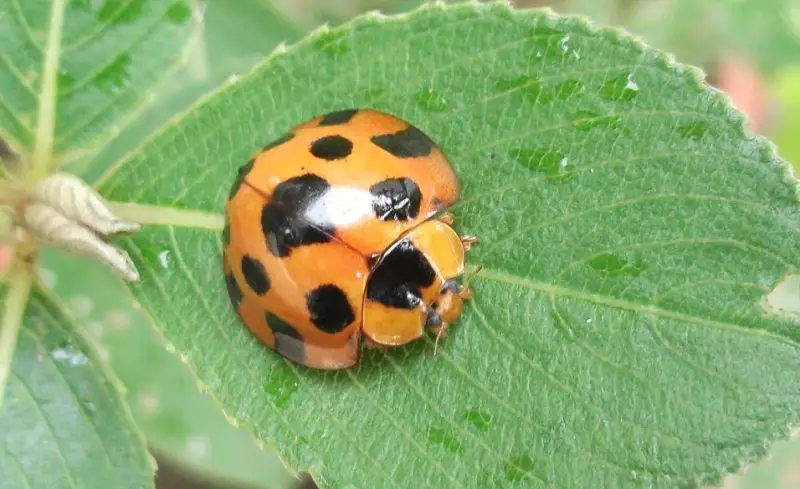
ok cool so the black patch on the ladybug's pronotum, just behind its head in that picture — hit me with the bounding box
[367,239,436,309]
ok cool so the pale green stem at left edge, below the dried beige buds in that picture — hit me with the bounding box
[0,263,33,408]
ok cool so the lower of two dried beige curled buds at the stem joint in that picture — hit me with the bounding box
[22,202,139,281]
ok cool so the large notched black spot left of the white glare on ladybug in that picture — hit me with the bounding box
[261,174,335,257]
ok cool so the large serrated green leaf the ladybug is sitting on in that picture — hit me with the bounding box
[99,4,800,488]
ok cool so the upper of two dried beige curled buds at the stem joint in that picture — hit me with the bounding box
[33,173,140,236]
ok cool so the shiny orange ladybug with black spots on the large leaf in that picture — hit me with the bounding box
[223,109,476,370]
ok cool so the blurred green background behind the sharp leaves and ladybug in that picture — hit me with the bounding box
[53,0,800,489]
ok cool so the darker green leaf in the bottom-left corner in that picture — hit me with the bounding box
[0,287,155,489]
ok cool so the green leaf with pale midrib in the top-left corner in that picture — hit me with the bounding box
[0,0,193,164]
